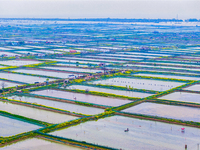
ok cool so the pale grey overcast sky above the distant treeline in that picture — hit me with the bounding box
[0,0,200,19]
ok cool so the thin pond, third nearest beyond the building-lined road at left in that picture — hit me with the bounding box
[13,69,77,78]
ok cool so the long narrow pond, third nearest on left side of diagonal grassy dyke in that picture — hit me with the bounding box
[7,95,104,115]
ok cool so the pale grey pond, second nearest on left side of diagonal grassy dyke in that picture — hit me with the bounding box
[0,102,77,123]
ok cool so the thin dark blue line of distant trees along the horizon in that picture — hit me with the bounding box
[0,18,200,23]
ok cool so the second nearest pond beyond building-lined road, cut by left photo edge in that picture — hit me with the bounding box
[0,72,55,83]
